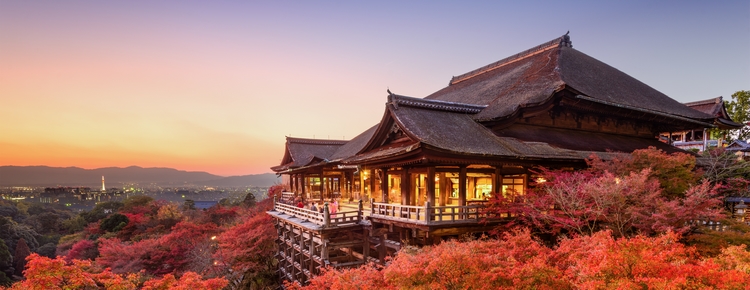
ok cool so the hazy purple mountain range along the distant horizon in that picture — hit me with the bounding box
[0,166,281,188]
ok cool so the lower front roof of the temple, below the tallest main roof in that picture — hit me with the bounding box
[344,95,682,163]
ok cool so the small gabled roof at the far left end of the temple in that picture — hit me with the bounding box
[271,137,348,172]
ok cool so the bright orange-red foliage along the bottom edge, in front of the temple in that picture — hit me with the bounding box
[300,231,750,289]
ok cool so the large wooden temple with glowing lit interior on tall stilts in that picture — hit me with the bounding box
[268,34,738,284]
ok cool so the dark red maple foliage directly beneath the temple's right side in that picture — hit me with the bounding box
[490,165,723,236]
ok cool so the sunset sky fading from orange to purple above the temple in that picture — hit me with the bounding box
[0,0,750,176]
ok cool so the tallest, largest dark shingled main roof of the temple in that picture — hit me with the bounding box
[426,35,713,121]
